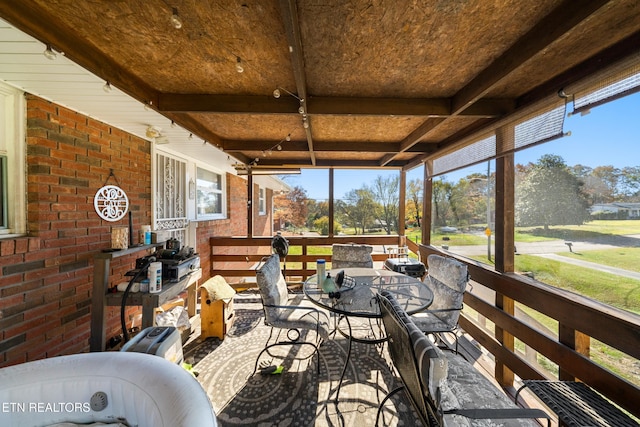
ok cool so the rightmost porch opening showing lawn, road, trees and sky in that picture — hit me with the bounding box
[514,94,640,384]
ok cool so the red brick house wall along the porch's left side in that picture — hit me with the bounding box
[0,95,260,367]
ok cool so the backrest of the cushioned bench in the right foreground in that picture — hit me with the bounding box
[378,291,447,426]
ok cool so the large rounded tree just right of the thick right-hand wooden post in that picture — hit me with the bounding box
[516,154,589,230]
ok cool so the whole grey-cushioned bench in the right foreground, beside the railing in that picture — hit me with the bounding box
[376,291,550,427]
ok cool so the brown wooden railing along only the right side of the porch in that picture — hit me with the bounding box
[419,245,640,417]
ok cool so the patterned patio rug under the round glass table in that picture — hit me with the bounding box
[185,292,417,427]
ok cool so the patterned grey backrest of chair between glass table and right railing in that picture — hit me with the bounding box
[424,254,469,327]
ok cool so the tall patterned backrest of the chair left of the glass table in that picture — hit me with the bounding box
[256,254,288,324]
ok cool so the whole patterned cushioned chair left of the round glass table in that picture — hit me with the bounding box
[253,254,329,373]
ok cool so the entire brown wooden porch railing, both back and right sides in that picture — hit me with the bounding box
[210,236,640,417]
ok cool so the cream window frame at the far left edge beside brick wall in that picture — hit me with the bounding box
[0,82,27,238]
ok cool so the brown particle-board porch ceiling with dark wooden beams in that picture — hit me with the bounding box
[0,0,640,171]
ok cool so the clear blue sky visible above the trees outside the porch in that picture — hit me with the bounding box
[286,93,640,199]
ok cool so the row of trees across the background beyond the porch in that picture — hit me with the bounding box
[274,154,640,235]
